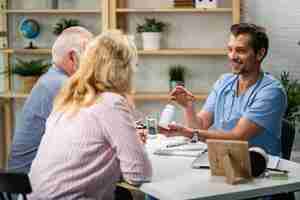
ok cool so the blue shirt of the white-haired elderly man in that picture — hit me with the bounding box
[8,66,68,173]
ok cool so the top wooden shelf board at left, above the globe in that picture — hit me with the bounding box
[0,9,101,14]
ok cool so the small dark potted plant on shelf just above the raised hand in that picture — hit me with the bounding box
[169,64,186,91]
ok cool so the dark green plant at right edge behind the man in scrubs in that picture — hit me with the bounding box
[280,71,300,126]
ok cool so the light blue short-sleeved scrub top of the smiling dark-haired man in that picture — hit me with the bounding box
[203,73,287,155]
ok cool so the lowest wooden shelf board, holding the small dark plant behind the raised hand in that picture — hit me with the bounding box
[0,92,207,101]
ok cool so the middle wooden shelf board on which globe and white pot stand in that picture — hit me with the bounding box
[1,48,227,56]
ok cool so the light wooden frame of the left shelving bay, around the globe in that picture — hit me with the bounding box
[0,0,104,168]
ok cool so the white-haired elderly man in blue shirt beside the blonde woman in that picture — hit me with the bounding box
[8,27,93,173]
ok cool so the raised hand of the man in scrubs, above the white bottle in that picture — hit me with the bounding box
[170,85,195,108]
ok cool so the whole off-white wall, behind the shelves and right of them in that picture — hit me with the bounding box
[0,0,300,157]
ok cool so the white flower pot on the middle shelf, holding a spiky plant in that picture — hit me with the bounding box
[142,32,161,50]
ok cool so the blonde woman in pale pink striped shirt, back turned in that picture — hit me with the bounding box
[29,31,152,200]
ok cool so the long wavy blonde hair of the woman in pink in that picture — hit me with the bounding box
[54,30,137,114]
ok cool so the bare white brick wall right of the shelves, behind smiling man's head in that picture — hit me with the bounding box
[242,0,300,154]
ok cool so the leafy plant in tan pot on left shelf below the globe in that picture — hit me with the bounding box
[12,58,50,93]
